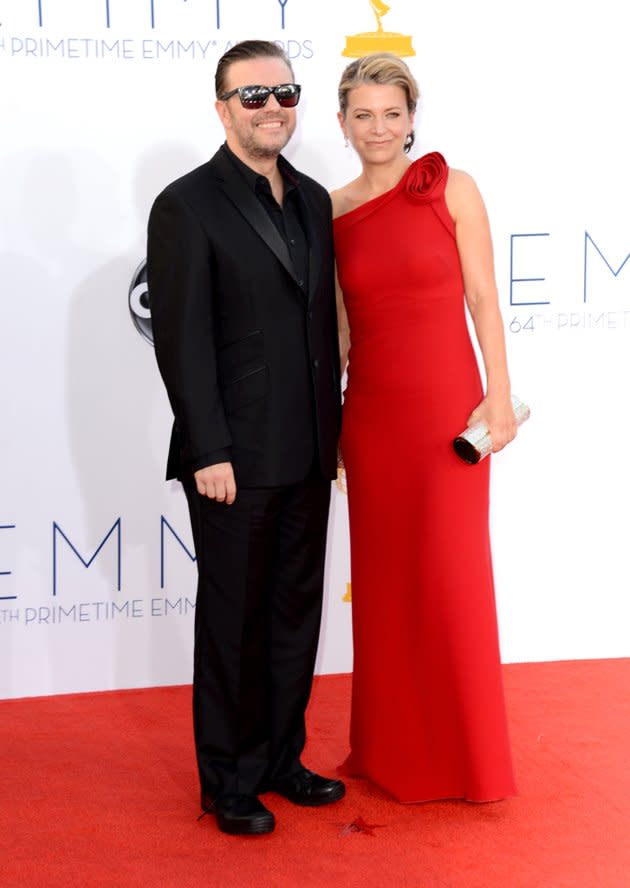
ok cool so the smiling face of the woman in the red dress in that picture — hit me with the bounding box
[338,83,414,164]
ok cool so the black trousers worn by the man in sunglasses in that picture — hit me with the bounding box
[184,474,331,795]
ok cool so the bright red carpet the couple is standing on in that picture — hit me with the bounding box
[0,660,630,888]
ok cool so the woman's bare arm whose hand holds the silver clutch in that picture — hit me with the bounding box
[445,170,516,451]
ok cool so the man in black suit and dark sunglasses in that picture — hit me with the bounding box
[148,40,345,834]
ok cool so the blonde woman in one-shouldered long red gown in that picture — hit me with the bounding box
[332,54,516,802]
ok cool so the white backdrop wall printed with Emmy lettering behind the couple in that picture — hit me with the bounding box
[0,0,630,697]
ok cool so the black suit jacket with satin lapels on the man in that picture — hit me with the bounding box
[147,148,341,487]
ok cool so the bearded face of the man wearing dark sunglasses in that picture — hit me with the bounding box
[216,58,296,160]
